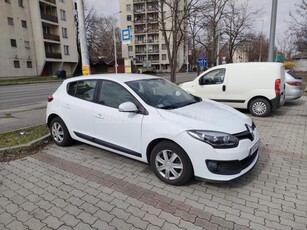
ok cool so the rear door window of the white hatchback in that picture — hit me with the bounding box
[67,80,97,101]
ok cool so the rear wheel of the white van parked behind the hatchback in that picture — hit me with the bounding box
[249,98,272,117]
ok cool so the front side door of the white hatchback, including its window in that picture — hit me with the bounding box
[93,80,144,157]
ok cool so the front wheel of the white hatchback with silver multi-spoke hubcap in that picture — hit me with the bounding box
[150,141,194,185]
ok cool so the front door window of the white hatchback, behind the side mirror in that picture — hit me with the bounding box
[99,81,137,108]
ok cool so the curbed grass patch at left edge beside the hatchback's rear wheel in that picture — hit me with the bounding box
[0,125,49,148]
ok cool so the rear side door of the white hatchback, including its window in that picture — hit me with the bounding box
[63,80,97,139]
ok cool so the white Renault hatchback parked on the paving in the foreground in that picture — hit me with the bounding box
[46,74,259,185]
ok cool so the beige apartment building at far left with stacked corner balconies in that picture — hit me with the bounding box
[0,0,78,77]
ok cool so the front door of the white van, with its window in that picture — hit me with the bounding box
[196,68,226,101]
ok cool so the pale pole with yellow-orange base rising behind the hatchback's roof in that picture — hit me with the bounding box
[77,0,91,75]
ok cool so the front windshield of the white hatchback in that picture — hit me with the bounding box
[126,78,201,109]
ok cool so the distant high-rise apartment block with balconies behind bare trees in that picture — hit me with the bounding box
[120,0,184,72]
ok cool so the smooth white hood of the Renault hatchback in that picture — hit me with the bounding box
[157,99,252,134]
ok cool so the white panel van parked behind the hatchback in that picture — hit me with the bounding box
[181,62,285,117]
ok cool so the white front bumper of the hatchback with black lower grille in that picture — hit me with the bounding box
[176,128,259,181]
